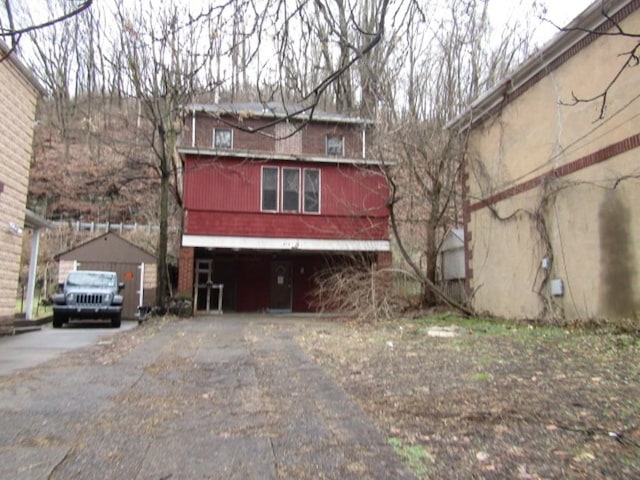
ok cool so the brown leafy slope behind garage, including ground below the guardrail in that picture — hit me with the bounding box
[21,98,181,293]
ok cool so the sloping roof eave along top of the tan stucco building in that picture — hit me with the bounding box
[446,0,639,131]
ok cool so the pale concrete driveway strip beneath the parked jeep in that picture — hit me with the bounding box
[0,321,137,376]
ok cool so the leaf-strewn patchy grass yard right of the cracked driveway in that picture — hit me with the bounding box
[303,314,640,480]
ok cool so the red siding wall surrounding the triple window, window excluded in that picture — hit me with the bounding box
[184,156,388,239]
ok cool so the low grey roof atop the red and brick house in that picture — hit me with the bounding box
[185,102,373,125]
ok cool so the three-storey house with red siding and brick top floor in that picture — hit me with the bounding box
[178,103,391,313]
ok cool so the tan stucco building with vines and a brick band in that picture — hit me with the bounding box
[449,0,640,319]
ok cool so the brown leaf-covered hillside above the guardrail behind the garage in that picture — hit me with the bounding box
[28,98,168,224]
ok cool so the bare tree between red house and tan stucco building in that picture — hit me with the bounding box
[379,0,528,310]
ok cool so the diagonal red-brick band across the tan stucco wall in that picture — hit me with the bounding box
[469,133,640,213]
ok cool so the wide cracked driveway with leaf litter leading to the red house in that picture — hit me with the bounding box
[0,315,413,480]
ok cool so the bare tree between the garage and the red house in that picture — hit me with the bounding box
[112,1,226,305]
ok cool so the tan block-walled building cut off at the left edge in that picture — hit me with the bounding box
[0,40,46,334]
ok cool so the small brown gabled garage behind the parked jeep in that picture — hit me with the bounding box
[56,232,157,319]
